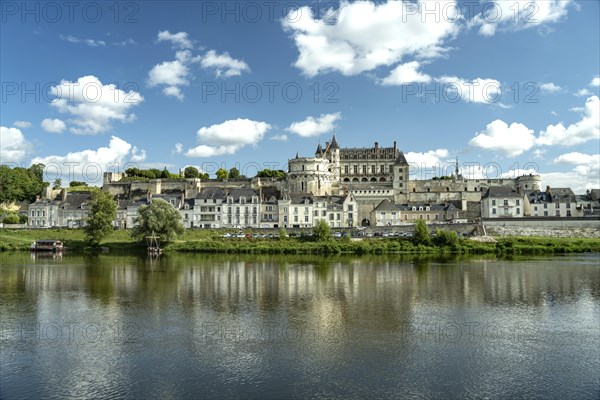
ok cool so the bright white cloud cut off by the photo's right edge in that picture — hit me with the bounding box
[537,96,600,146]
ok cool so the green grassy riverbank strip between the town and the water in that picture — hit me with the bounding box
[0,229,600,255]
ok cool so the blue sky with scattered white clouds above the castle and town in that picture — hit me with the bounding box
[0,0,600,192]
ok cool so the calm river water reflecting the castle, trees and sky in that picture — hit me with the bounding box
[0,254,600,399]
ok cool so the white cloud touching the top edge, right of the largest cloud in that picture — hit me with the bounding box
[469,0,573,36]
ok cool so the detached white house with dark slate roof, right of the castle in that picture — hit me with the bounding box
[481,186,526,218]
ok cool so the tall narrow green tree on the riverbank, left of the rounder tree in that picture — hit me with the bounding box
[84,190,117,247]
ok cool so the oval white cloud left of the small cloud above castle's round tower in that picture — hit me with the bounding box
[185,118,271,157]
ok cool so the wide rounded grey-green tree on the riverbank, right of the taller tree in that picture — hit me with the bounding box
[133,199,184,241]
